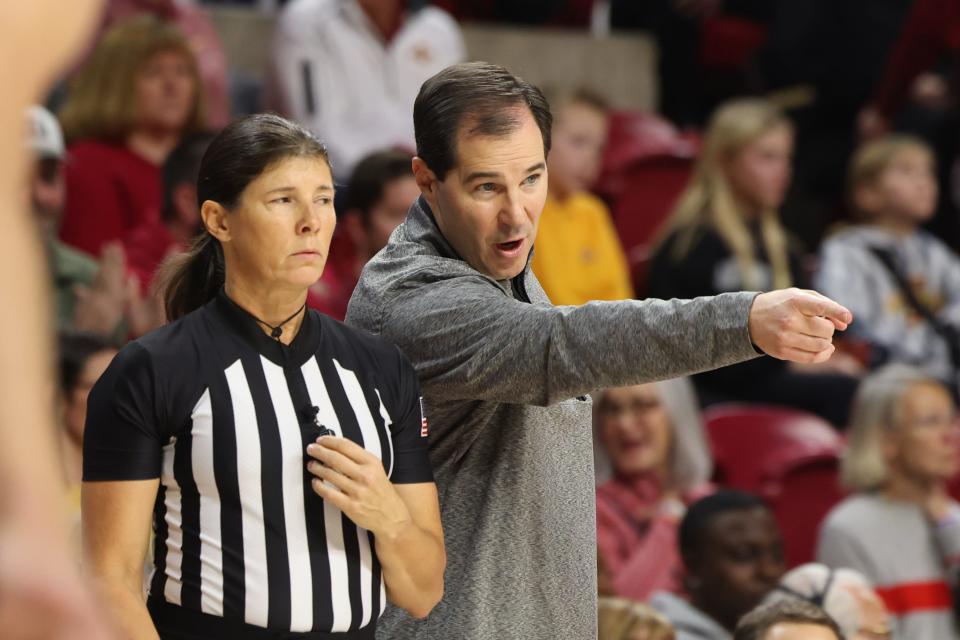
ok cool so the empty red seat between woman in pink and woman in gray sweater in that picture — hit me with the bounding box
[704,404,843,567]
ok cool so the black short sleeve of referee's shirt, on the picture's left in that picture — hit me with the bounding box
[83,342,164,482]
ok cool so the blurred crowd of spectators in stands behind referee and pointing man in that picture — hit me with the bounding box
[30,0,960,640]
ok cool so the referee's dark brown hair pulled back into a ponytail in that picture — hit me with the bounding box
[160,114,330,321]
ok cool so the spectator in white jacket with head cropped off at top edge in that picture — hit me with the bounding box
[272,0,466,180]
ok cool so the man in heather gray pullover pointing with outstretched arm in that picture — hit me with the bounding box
[347,63,851,640]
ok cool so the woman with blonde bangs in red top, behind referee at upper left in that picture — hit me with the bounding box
[59,16,206,262]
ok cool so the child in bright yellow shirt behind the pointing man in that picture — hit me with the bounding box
[533,90,633,305]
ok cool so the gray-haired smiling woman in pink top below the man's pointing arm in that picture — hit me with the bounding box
[594,378,712,600]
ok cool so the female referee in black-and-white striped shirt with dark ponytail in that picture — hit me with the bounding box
[83,115,446,640]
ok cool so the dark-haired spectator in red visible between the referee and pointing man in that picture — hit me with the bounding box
[307,150,420,320]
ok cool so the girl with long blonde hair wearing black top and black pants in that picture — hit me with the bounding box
[650,98,857,427]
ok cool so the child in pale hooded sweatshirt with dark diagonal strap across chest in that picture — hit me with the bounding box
[814,135,960,392]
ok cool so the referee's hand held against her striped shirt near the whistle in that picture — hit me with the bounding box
[307,436,412,536]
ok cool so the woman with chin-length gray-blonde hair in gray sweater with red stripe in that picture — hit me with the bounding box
[817,365,960,640]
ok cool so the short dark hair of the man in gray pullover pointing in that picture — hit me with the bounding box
[413,62,553,180]
